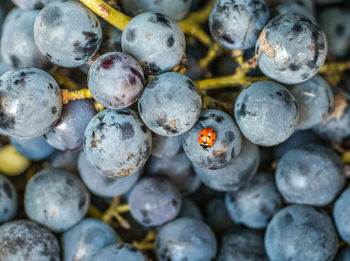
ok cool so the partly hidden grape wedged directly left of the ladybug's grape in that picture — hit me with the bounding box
[151,133,182,158]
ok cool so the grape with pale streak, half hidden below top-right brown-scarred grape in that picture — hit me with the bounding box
[289,75,333,130]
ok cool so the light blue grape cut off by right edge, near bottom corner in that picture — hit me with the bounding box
[333,188,350,243]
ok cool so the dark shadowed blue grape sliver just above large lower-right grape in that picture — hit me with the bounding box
[274,130,321,159]
